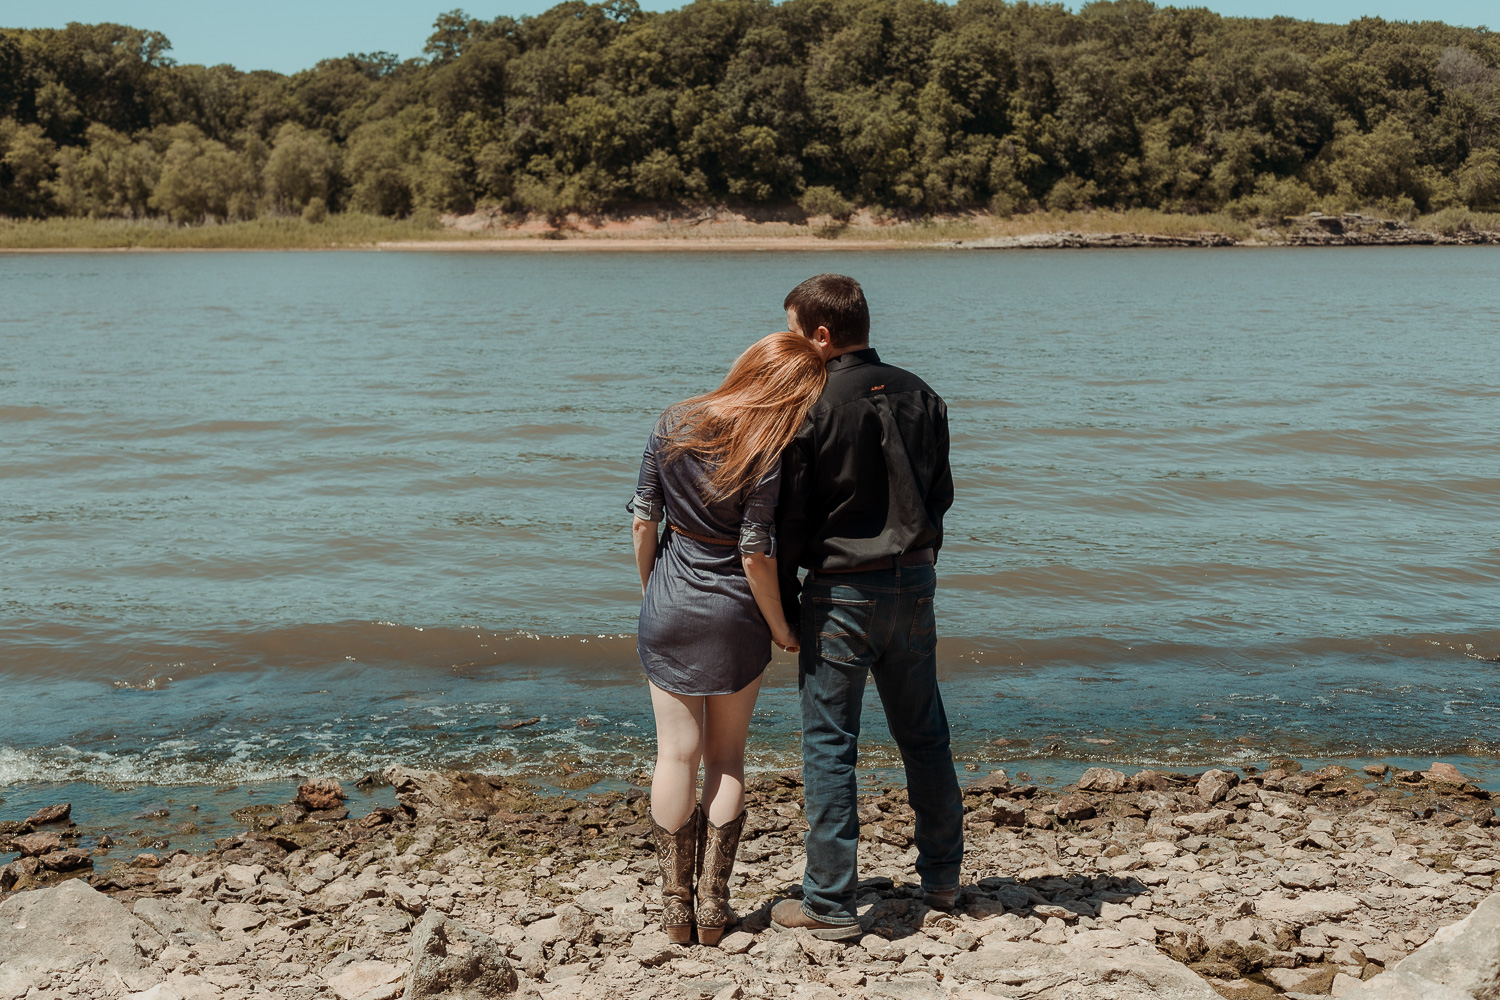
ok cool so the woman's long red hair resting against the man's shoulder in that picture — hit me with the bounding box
[665,331,828,499]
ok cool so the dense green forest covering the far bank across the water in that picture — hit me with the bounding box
[0,0,1500,222]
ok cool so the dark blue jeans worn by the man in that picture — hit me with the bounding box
[798,565,963,924]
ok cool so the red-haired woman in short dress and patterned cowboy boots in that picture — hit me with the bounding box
[630,333,828,945]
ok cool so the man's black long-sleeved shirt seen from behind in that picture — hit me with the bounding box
[776,348,953,621]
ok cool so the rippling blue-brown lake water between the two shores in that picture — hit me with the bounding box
[0,247,1500,839]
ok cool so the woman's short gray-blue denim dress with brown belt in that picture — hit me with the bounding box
[629,417,782,696]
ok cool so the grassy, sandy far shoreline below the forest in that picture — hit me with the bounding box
[0,211,1500,253]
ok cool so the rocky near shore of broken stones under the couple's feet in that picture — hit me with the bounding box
[0,760,1500,1000]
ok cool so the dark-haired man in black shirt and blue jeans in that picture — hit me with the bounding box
[771,274,963,940]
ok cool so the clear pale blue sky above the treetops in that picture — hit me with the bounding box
[0,0,1500,72]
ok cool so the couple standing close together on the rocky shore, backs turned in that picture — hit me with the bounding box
[630,274,963,945]
